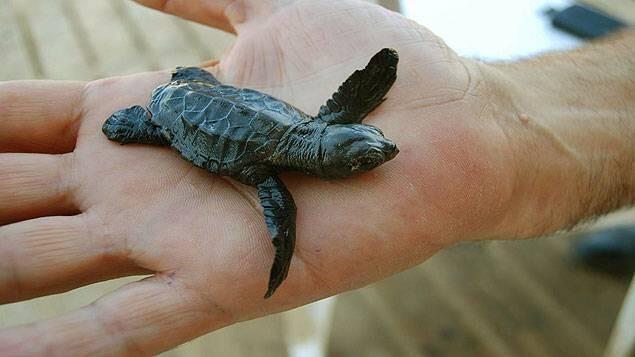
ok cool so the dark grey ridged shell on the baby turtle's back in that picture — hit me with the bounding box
[149,81,311,177]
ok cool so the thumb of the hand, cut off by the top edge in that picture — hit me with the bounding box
[135,0,289,33]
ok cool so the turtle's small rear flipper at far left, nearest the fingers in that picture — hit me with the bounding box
[101,105,170,145]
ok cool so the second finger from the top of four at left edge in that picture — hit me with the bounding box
[0,154,78,224]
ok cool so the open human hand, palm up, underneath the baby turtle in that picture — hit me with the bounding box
[0,0,511,354]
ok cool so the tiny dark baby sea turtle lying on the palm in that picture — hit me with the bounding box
[102,48,399,298]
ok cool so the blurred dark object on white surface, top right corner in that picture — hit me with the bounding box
[547,5,626,39]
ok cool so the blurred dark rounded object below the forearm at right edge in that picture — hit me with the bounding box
[574,225,635,274]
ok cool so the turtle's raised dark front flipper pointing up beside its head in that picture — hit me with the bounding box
[315,48,399,124]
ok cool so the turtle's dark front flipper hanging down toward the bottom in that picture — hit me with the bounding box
[257,176,296,299]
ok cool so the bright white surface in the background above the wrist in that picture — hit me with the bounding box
[401,0,581,60]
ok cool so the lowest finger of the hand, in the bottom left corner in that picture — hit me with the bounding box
[0,277,230,356]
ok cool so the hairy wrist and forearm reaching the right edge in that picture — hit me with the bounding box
[483,32,635,236]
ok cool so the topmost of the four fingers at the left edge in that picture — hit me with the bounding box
[0,81,84,154]
